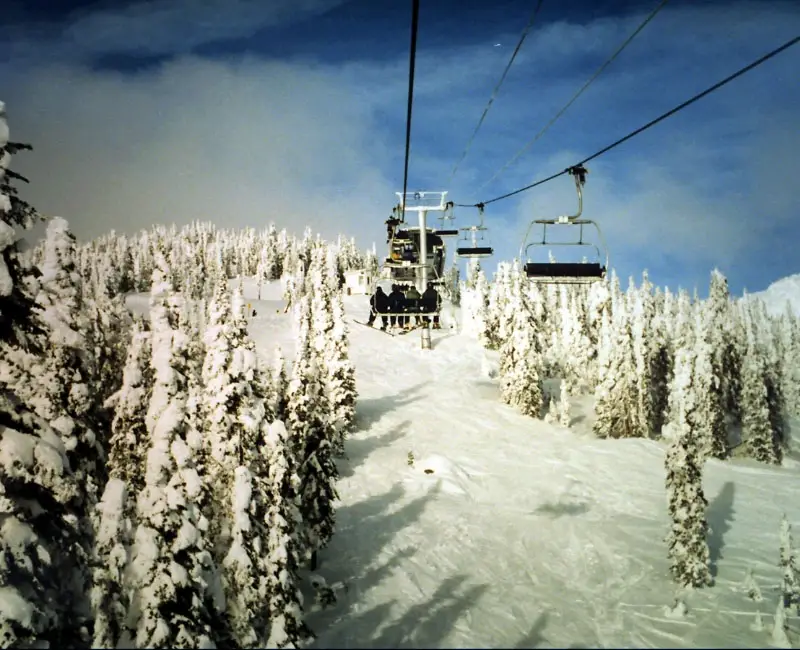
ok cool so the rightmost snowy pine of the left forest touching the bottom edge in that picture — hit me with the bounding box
[262,420,313,648]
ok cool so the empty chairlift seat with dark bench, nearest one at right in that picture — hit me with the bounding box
[520,165,608,284]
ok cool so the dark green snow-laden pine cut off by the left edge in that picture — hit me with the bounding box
[0,102,89,647]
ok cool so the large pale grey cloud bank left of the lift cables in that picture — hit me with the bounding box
[3,59,393,237]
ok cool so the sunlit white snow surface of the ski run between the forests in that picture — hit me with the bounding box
[129,281,800,648]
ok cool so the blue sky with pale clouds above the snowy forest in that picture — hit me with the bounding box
[0,0,800,294]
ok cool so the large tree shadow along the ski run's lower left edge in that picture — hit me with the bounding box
[307,484,440,648]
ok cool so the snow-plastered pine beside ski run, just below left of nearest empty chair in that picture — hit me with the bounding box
[499,270,543,418]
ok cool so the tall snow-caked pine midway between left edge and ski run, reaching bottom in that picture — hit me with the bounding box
[128,256,225,648]
